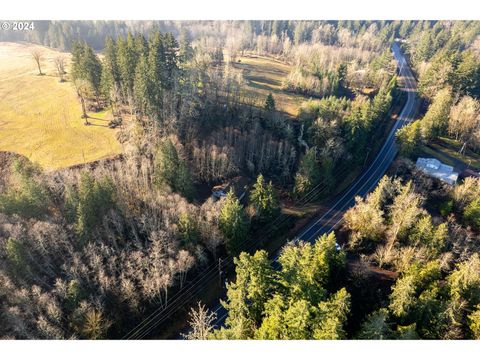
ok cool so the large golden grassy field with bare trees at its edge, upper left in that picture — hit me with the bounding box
[0,42,121,169]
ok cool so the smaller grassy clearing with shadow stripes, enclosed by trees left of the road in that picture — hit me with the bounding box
[234,55,308,116]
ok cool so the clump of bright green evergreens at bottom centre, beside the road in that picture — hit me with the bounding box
[214,234,350,340]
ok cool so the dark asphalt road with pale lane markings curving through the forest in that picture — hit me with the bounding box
[215,43,419,326]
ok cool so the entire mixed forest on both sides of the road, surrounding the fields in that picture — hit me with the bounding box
[0,21,480,339]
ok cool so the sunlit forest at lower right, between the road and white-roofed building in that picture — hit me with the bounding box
[187,167,480,339]
